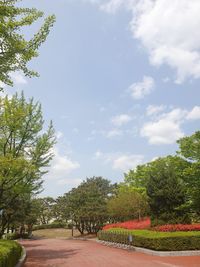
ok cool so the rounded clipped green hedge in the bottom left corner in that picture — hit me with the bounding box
[0,240,22,267]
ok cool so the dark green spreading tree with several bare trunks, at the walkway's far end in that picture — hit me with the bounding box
[65,177,113,234]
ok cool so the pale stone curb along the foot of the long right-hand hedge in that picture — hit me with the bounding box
[96,240,200,257]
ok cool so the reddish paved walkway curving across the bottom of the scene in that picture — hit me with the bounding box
[21,239,200,267]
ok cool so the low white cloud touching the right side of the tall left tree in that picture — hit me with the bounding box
[47,148,80,182]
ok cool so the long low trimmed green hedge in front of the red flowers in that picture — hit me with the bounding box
[98,229,200,251]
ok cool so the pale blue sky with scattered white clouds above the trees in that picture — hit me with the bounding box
[1,0,200,197]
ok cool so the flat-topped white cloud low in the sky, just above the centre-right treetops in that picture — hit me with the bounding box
[95,150,144,172]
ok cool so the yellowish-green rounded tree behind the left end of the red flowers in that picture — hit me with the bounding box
[108,184,148,222]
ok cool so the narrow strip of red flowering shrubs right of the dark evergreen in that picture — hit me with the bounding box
[153,224,200,232]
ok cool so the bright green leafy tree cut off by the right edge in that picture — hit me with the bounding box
[178,131,200,217]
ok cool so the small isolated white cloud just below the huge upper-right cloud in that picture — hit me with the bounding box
[129,76,155,99]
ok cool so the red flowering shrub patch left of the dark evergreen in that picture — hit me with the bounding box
[103,218,151,230]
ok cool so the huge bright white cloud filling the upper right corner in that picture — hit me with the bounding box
[93,0,200,83]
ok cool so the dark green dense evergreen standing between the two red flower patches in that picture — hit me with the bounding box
[147,157,190,225]
